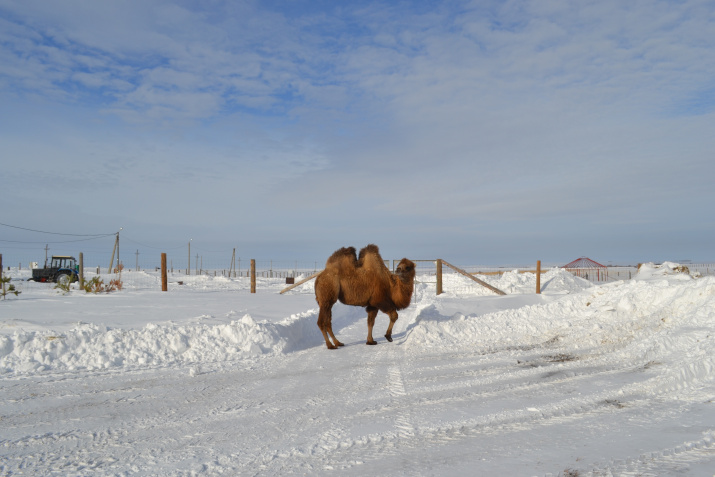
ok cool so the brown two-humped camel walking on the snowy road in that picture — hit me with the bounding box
[315,244,415,349]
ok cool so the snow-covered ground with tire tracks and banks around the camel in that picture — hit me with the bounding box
[0,263,715,476]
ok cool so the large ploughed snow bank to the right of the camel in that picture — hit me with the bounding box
[407,267,715,364]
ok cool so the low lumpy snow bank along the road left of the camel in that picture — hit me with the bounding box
[0,310,323,374]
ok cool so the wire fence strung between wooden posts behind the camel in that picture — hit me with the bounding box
[3,251,715,293]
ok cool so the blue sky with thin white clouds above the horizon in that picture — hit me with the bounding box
[0,0,715,264]
